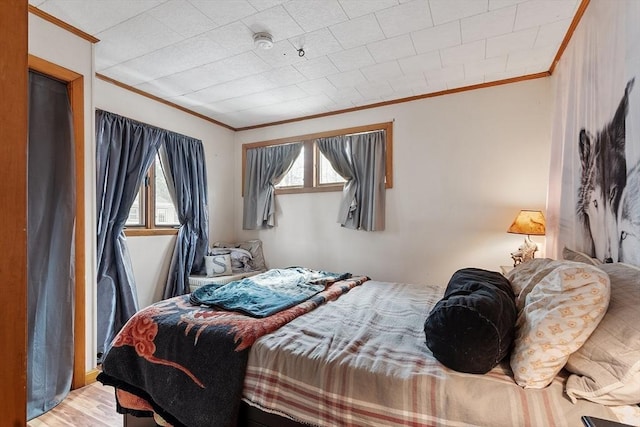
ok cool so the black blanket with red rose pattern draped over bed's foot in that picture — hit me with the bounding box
[98,270,368,427]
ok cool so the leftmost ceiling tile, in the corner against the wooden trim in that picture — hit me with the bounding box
[34,0,164,35]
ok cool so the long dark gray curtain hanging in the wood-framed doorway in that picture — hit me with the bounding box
[27,72,76,419]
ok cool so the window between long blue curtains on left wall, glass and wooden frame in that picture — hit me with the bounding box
[125,155,180,236]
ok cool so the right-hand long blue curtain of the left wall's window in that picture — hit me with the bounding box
[156,132,209,298]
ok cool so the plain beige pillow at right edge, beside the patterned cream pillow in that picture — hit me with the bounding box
[565,263,640,405]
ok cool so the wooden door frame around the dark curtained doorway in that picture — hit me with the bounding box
[28,55,86,389]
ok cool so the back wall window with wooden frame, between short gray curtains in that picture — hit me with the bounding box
[242,122,393,194]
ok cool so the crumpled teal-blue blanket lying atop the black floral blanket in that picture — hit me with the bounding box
[190,267,351,317]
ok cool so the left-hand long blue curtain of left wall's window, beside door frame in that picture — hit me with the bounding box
[96,110,162,355]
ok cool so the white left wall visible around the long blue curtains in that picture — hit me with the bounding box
[94,79,234,307]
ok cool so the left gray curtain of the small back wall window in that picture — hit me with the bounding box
[242,142,302,230]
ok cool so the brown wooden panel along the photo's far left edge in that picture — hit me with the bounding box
[0,0,28,426]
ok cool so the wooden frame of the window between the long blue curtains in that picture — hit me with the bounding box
[124,154,180,236]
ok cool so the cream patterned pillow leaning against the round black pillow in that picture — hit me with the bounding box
[507,258,610,388]
